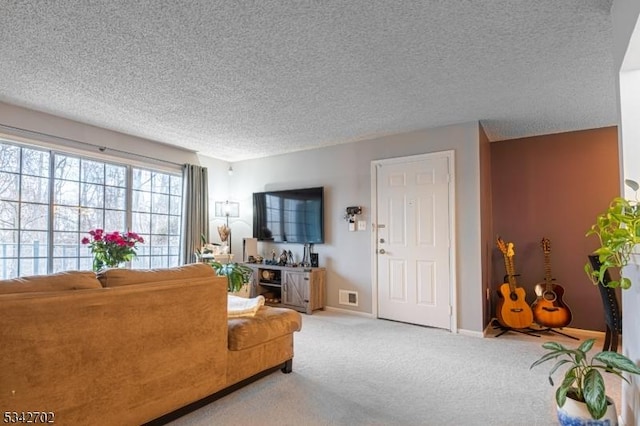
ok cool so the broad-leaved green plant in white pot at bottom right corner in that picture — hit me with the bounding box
[530,339,640,426]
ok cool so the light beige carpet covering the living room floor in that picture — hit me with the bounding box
[172,311,620,426]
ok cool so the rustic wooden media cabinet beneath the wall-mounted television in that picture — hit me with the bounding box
[246,263,325,314]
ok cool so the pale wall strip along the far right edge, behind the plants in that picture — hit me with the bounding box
[611,0,640,425]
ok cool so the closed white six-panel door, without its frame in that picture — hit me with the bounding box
[374,152,453,330]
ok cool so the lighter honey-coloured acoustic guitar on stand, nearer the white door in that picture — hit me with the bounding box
[496,237,533,329]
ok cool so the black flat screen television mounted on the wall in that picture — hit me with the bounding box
[253,186,324,244]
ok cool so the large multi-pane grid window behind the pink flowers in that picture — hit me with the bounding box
[0,139,182,279]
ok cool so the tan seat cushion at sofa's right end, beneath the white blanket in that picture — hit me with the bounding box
[228,306,302,351]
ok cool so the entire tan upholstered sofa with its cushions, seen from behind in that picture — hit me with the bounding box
[0,264,301,425]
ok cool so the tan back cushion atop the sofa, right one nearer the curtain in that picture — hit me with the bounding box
[98,263,215,287]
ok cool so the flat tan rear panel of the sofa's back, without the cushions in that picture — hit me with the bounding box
[0,275,227,424]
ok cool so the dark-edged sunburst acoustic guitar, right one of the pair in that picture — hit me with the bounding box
[531,238,571,328]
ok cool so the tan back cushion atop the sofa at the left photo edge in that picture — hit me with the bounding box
[0,271,102,294]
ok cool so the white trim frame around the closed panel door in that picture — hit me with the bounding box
[371,150,458,333]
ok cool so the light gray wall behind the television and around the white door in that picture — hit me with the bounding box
[212,122,484,333]
